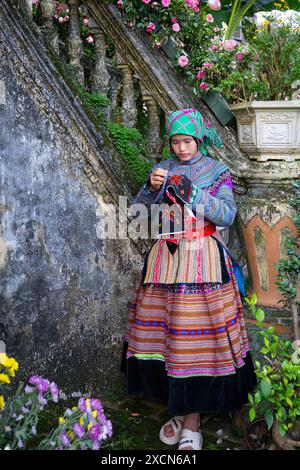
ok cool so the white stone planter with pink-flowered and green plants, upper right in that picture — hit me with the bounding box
[200,16,300,161]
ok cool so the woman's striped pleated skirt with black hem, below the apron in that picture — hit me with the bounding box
[121,239,257,415]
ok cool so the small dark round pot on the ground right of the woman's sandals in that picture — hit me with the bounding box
[244,418,272,450]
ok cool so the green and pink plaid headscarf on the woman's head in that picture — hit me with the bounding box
[166,108,223,155]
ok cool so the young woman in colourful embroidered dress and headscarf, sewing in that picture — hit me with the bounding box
[121,109,257,450]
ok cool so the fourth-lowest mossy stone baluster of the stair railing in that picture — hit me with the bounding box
[67,0,84,85]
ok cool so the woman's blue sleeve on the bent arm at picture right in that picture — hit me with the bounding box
[192,169,237,227]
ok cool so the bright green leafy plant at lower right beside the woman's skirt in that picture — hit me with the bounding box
[245,294,300,450]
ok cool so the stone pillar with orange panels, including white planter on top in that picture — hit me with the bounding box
[230,100,300,309]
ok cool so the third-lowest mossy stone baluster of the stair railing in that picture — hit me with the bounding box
[89,18,110,96]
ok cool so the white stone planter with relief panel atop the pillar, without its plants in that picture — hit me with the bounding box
[230,100,300,162]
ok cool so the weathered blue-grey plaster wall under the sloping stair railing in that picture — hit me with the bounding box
[0,1,142,391]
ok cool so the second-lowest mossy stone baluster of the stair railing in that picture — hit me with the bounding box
[117,52,137,127]
